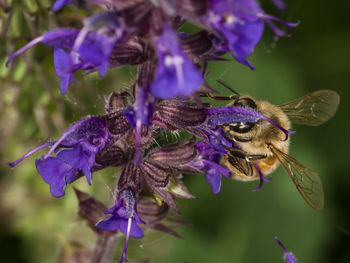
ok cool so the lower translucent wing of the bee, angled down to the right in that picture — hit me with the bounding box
[270,145,324,210]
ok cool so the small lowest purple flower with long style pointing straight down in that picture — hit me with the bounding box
[97,189,144,262]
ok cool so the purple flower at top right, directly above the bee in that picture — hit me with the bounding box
[203,0,297,69]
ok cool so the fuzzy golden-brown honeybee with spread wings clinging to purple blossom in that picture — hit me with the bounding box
[208,81,339,210]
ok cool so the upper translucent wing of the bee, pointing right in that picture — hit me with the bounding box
[279,90,340,126]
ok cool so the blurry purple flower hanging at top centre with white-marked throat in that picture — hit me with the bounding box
[151,25,203,99]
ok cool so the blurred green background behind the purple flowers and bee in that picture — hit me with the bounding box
[0,0,350,263]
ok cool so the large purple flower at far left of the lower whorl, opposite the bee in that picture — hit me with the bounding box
[9,117,111,197]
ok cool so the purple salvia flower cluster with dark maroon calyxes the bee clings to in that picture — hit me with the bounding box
[7,0,296,262]
